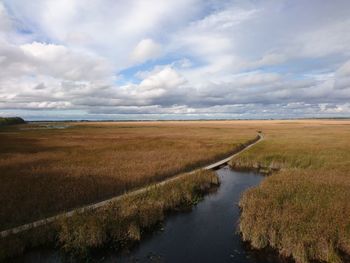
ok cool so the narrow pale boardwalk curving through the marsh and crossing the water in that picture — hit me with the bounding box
[0,133,264,238]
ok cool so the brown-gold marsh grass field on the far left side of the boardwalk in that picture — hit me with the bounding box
[0,122,256,229]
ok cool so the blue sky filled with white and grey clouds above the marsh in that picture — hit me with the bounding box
[0,0,350,120]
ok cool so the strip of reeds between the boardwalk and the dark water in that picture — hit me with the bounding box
[0,171,219,259]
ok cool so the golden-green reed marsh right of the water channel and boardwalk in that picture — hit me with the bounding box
[231,121,350,262]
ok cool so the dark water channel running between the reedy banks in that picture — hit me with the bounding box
[13,167,284,263]
